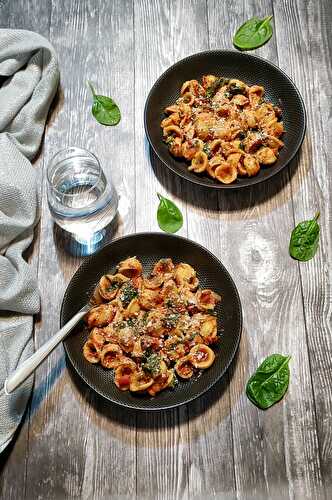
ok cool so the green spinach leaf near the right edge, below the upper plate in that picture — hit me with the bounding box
[289,212,320,261]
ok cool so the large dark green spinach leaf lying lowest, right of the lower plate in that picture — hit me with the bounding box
[246,354,291,410]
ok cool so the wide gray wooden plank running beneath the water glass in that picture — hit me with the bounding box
[23,0,136,499]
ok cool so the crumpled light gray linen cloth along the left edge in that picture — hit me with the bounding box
[0,29,59,452]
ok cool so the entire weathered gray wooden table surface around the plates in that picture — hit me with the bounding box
[0,0,332,500]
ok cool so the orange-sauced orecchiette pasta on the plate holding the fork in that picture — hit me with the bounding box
[83,257,220,396]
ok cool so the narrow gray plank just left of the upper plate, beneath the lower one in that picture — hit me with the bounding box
[134,0,188,499]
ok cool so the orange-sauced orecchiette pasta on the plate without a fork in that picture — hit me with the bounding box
[161,75,284,184]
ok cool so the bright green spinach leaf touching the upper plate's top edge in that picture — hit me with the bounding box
[233,16,273,50]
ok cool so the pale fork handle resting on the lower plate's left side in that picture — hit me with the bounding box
[4,305,90,395]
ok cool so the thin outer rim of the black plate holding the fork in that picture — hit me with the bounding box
[60,231,243,412]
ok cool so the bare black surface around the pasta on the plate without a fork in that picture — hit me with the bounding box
[144,50,306,189]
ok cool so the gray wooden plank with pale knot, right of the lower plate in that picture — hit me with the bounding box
[208,1,321,498]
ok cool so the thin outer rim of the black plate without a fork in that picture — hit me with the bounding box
[144,49,307,190]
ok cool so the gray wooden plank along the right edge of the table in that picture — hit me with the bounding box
[274,1,332,498]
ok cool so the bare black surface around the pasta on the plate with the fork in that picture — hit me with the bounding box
[61,233,242,410]
